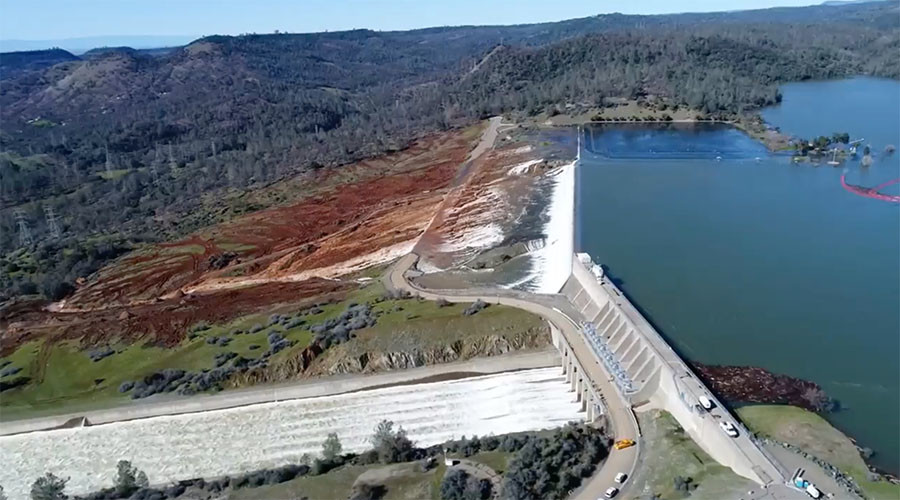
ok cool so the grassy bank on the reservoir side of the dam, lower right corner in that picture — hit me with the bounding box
[737,405,900,499]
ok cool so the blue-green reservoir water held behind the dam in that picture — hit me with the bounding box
[576,78,900,472]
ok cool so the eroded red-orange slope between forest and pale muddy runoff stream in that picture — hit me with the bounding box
[60,127,472,311]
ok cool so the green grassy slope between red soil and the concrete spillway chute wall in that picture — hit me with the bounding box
[0,282,542,420]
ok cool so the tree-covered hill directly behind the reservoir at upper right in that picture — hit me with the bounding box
[460,24,900,119]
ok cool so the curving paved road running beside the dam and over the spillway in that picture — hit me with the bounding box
[383,254,640,500]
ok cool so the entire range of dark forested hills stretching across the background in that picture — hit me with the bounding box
[0,2,900,301]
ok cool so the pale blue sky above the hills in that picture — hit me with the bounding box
[0,0,817,40]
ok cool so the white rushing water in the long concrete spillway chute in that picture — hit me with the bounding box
[0,368,583,499]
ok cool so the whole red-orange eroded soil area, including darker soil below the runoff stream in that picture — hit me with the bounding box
[0,130,478,353]
